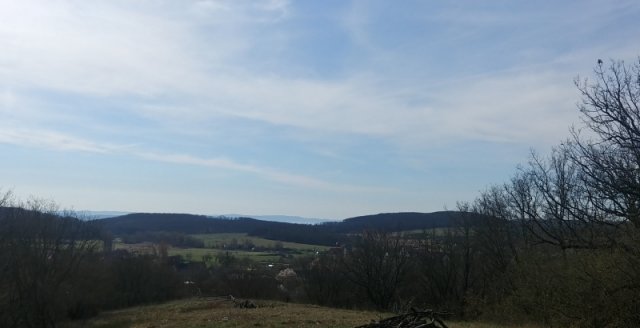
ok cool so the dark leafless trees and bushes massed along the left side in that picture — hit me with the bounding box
[0,196,191,328]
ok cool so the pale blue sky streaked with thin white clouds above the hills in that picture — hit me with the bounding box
[0,0,640,219]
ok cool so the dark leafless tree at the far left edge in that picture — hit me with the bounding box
[0,199,98,327]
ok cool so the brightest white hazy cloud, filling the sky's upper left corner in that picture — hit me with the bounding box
[0,1,283,96]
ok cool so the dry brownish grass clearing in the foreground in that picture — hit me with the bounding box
[62,299,534,328]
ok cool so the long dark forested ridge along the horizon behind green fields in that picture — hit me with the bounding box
[96,212,456,245]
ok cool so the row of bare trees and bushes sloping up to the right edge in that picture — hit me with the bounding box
[300,60,640,327]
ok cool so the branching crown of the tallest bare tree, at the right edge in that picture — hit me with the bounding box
[565,58,640,228]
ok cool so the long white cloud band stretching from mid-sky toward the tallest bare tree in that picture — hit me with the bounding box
[170,69,577,146]
